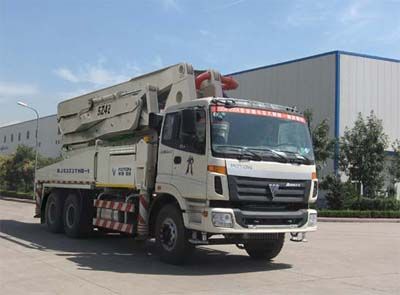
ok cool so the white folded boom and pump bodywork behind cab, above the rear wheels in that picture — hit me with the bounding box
[37,63,222,189]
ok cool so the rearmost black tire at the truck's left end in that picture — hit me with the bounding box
[45,192,65,233]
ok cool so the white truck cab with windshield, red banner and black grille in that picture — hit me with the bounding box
[156,98,318,234]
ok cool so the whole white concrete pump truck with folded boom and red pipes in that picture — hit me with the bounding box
[35,63,318,264]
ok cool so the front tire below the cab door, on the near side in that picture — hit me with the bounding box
[155,205,194,265]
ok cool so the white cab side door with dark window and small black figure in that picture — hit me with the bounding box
[171,107,207,199]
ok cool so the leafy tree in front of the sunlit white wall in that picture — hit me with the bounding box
[339,111,388,198]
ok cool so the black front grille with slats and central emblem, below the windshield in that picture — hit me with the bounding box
[228,175,311,203]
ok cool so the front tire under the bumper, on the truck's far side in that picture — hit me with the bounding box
[244,233,285,260]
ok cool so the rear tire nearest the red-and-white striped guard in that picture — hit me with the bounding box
[63,193,93,238]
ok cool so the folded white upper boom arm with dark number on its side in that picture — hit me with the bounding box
[58,63,197,146]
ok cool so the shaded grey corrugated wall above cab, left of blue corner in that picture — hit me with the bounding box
[228,53,335,136]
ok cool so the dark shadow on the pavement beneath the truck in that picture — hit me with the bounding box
[0,220,292,276]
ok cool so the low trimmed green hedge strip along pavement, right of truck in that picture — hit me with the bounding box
[318,210,400,218]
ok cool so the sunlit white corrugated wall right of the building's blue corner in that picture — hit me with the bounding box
[339,54,400,147]
